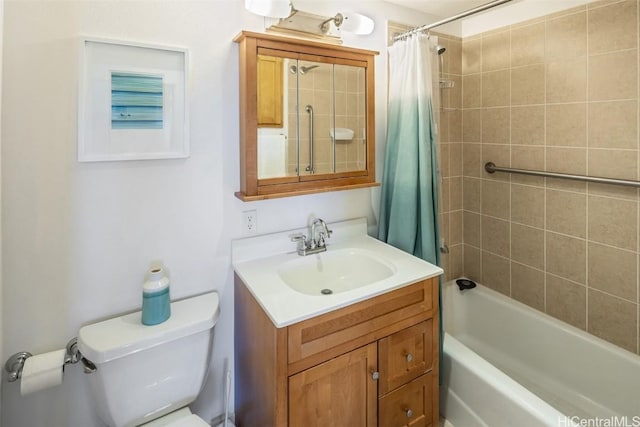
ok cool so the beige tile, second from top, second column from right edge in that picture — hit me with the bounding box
[546,57,587,103]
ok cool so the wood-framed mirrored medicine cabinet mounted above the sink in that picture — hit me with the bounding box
[234,31,379,201]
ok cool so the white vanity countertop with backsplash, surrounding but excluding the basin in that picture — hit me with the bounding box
[231,218,443,328]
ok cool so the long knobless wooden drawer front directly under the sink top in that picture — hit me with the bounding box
[287,279,437,374]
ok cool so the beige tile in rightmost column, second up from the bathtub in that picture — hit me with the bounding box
[587,243,638,301]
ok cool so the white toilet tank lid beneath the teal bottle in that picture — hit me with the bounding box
[78,292,220,363]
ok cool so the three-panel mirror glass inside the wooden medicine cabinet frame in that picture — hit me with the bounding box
[257,55,367,179]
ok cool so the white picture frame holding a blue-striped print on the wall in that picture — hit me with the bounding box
[78,37,189,162]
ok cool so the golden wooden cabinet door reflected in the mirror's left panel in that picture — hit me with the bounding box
[258,55,283,128]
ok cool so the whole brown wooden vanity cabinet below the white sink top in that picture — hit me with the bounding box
[235,276,439,427]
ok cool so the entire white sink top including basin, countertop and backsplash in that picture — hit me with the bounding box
[231,218,442,328]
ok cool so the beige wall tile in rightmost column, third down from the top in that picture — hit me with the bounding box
[589,99,638,150]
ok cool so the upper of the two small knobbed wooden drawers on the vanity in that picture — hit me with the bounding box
[378,319,433,396]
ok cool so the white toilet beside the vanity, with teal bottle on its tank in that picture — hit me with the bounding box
[78,292,220,427]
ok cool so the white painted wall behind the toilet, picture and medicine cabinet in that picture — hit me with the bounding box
[1,0,436,427]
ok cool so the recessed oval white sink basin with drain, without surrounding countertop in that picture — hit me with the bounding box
[278,249,396,295]
